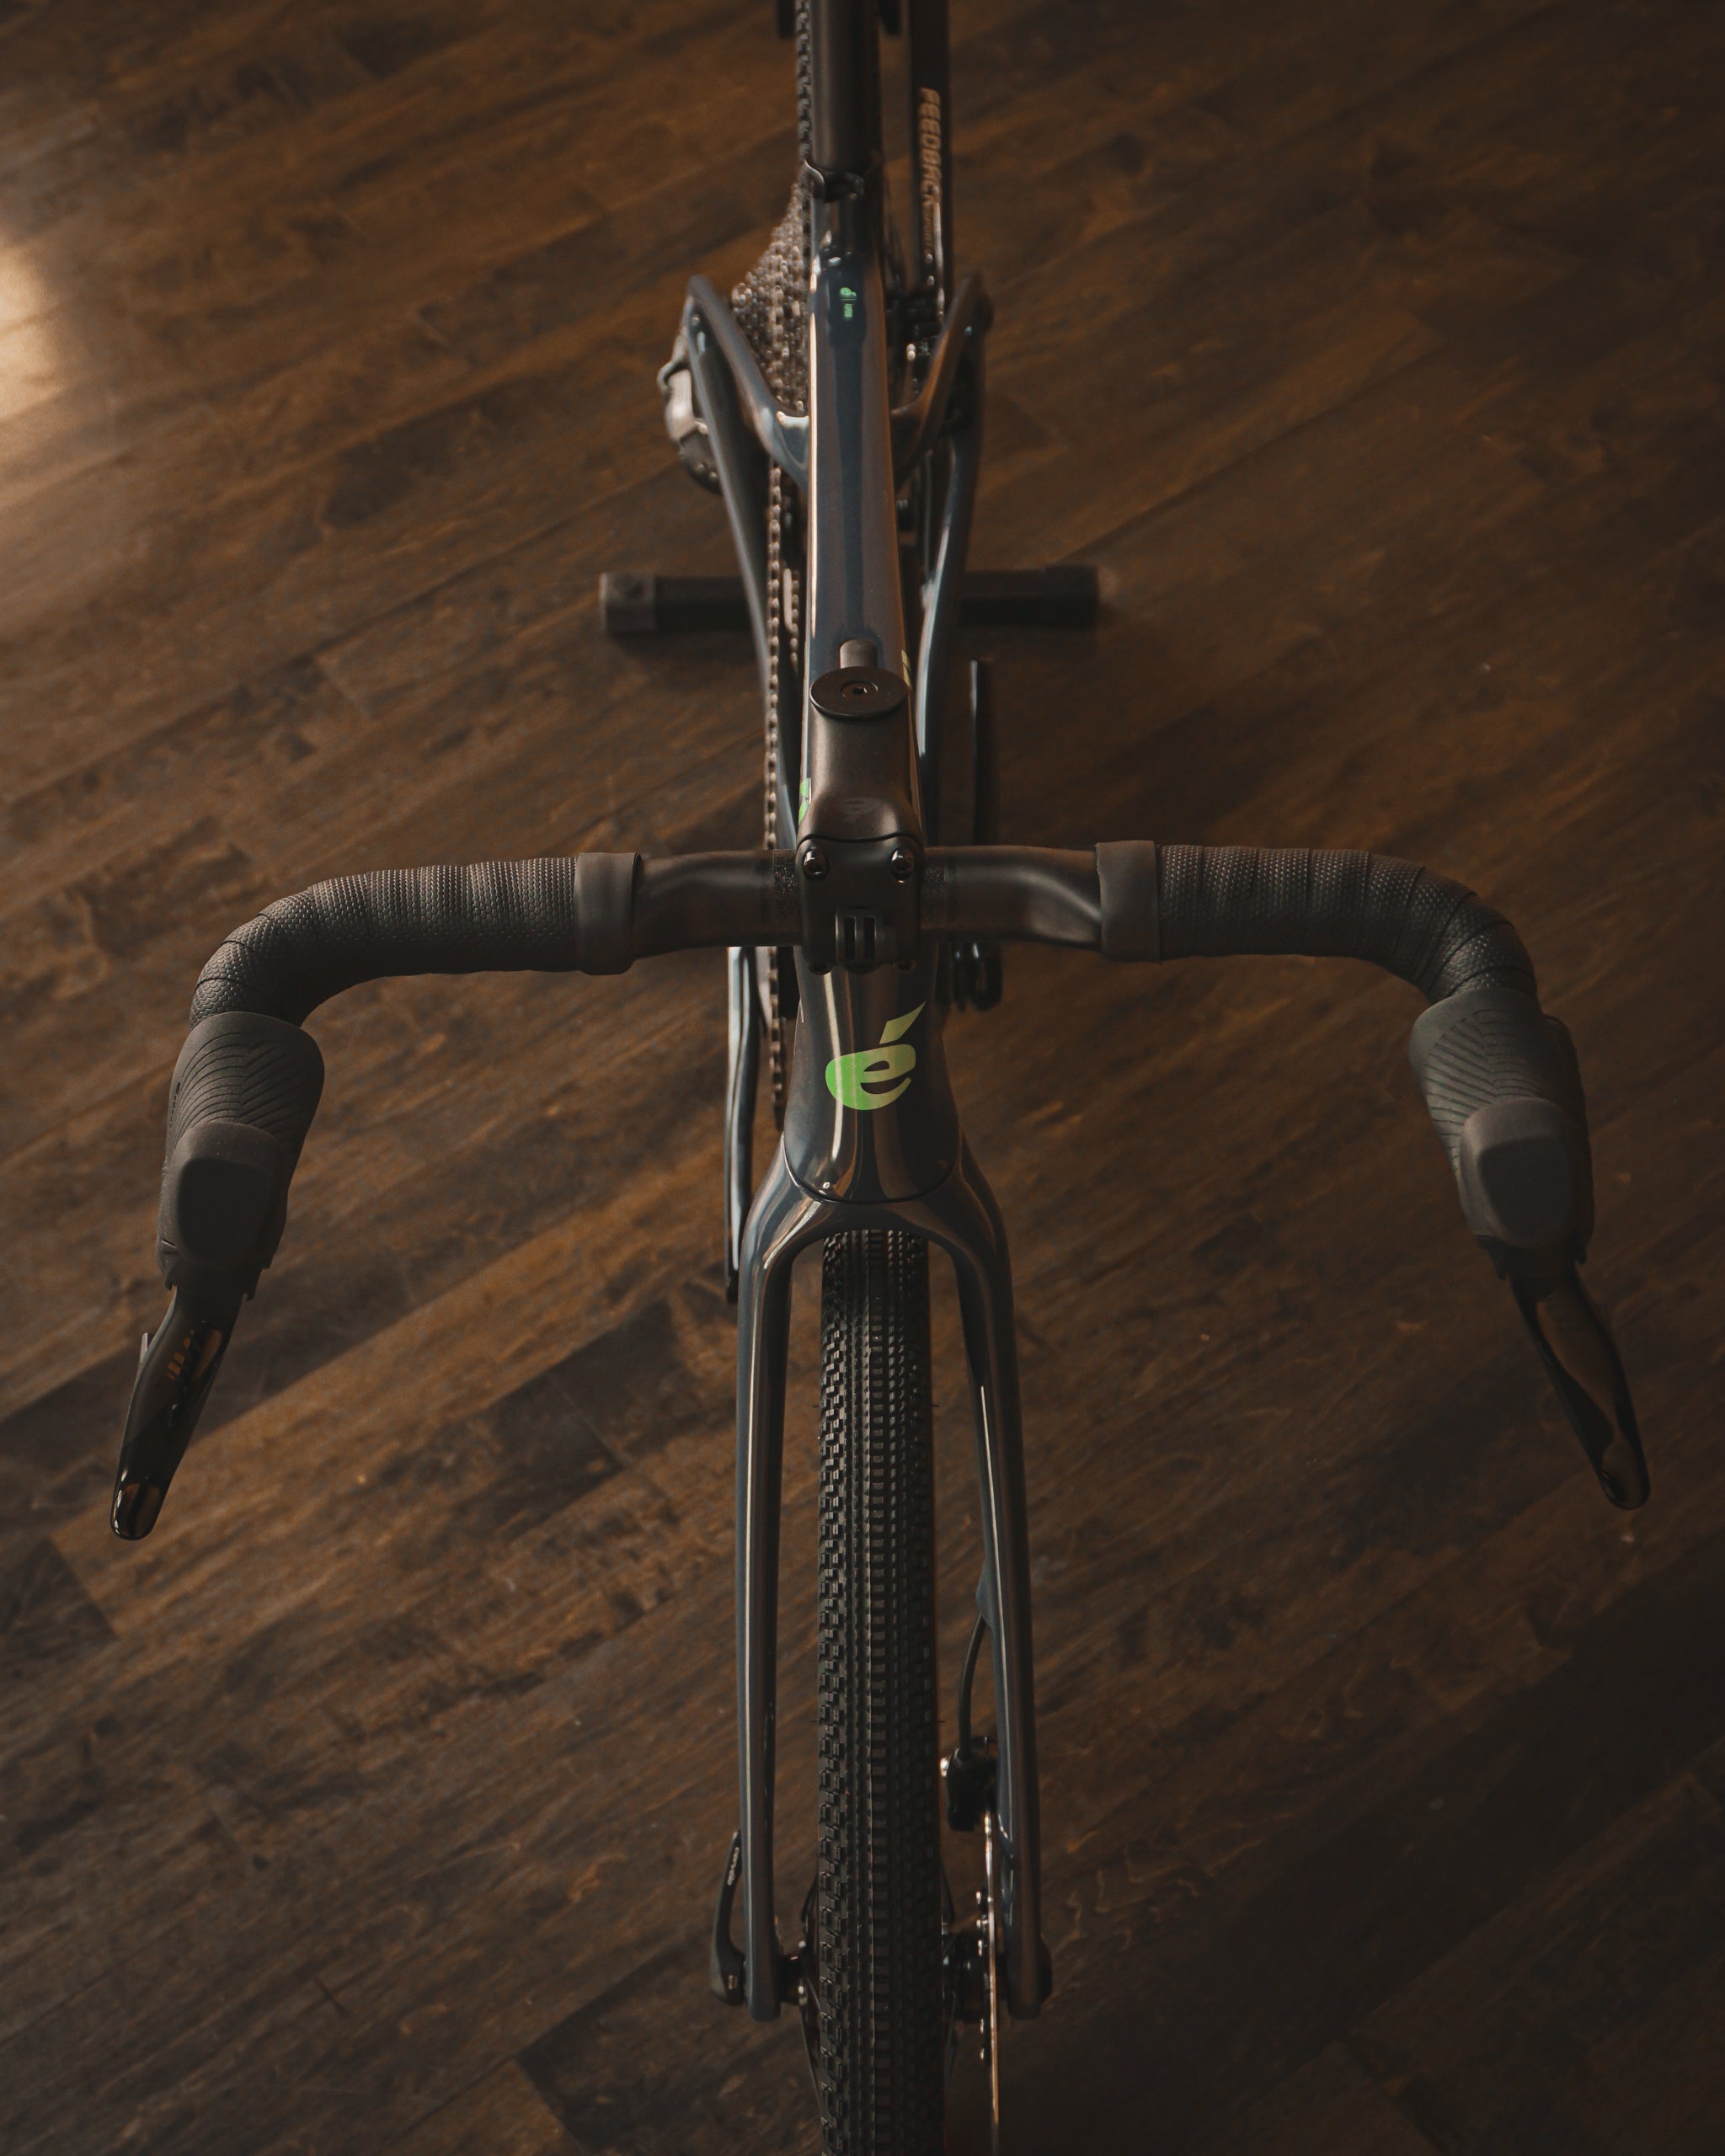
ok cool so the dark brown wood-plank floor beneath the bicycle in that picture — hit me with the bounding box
[0,0,1725,2156]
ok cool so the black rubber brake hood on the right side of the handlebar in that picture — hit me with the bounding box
[1408,987,1594,1257]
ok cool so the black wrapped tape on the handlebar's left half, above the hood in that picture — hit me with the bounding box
[192,854,638,1027]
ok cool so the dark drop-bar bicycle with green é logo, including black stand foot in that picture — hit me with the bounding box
[112,0,1648,2152]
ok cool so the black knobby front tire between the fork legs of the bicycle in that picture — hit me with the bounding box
[809,1229,947,2156]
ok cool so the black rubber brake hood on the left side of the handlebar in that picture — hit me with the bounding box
[155,1011,323,1302]
